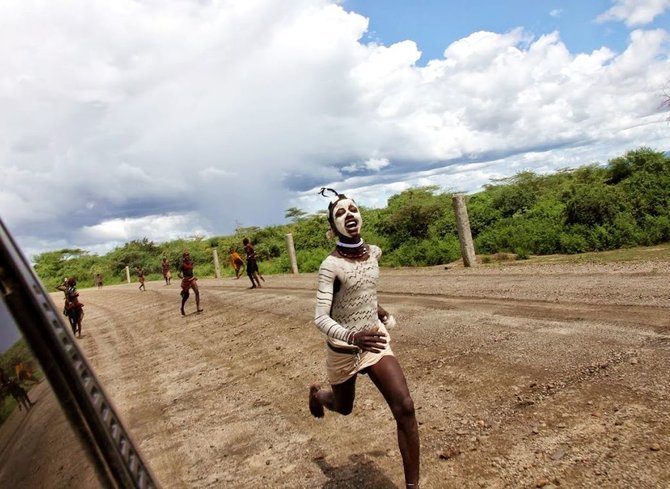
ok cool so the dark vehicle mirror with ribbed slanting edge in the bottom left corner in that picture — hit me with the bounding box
[0,220,159,489]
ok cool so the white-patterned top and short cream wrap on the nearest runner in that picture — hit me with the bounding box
[314,245,393,384]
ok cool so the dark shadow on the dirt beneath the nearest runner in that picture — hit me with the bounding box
[314,453,397,489]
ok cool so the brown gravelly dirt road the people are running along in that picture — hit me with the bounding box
[1,262,670,489]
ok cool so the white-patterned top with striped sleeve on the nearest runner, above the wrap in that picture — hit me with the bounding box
[314,245,382,341]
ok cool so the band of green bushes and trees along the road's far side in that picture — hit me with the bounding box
[33,147,670,290]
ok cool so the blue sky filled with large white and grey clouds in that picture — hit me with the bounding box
[0,0,670,257]
